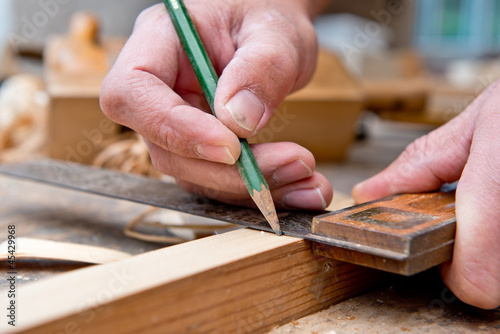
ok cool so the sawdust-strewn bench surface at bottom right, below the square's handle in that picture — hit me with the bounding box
[270,269,500,334]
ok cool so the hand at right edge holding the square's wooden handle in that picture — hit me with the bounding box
[353,81,500,309]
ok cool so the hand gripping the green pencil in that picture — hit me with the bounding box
[101,0,333,209]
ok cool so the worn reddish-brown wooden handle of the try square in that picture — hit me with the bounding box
[312,191,456,275]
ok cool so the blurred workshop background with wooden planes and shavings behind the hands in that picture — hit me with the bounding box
[0,0,500,191]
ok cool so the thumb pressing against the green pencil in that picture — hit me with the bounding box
[215,11,317,138]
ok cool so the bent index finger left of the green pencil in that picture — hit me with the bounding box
[101,4,240,163]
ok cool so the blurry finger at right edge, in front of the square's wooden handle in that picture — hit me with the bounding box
[441,82,500,309]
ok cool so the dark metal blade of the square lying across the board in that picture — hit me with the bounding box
[0,159,408,261]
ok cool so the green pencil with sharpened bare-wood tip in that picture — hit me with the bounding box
[163,0,281,235]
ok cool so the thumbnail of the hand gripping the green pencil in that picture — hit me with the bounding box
[225,89,265,132]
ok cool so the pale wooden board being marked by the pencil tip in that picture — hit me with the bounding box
[1,229,382,333]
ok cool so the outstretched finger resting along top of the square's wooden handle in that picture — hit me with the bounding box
[352,85,495,203]
